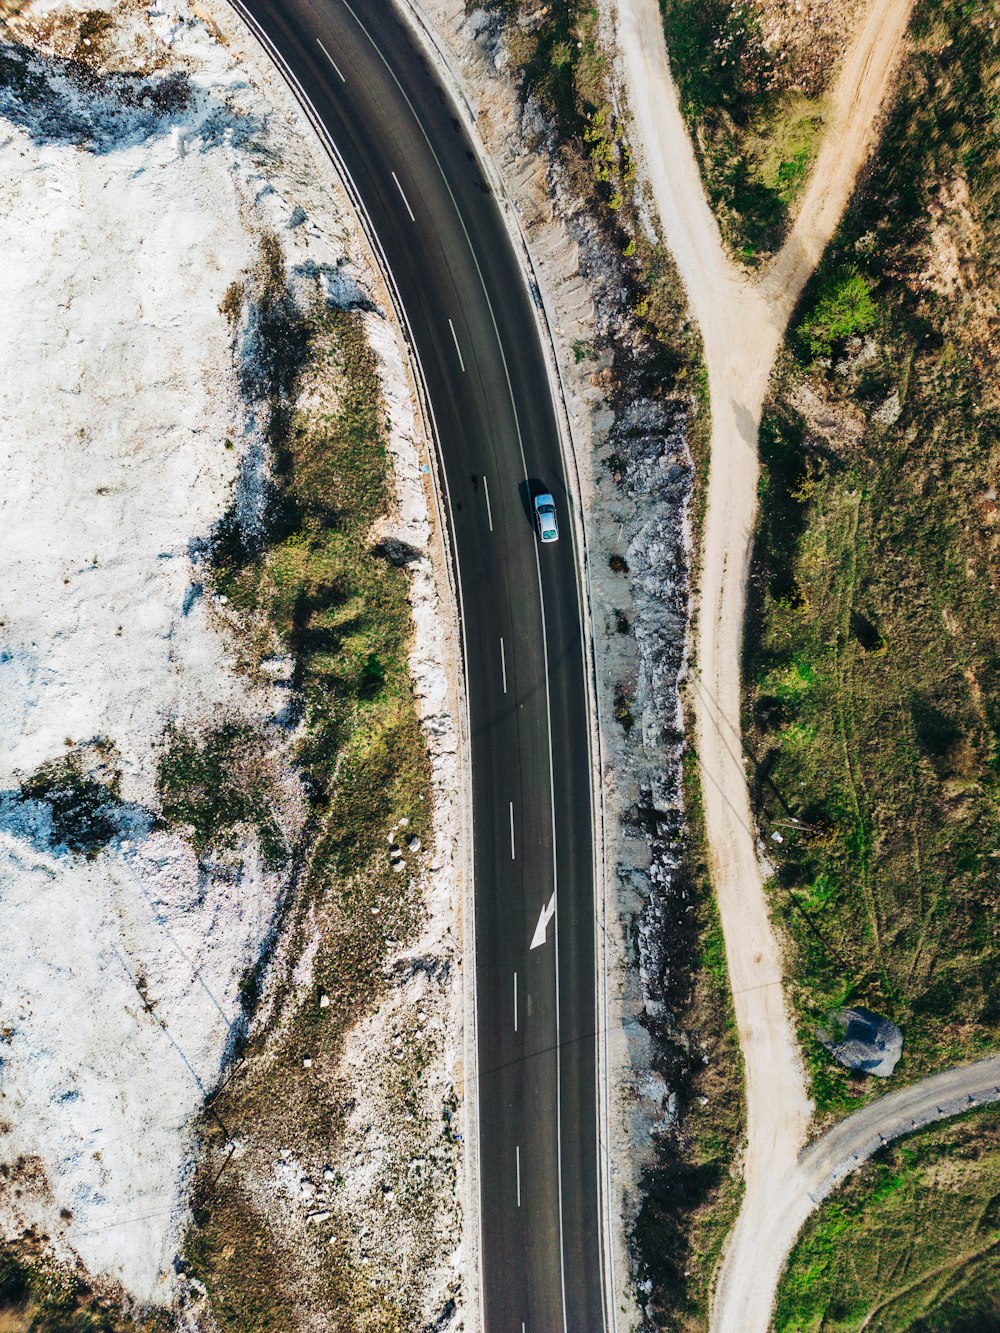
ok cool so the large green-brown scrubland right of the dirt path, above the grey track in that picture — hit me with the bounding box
[745,0,1000,1117]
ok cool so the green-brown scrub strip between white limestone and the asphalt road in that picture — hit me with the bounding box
[185,237,442,1333]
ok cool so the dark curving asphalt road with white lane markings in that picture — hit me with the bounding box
[237,0,605,1333]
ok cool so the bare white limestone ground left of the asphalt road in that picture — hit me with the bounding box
[0,0,460,1302]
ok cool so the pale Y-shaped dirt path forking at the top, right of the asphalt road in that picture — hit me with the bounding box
[609,0,913,1333]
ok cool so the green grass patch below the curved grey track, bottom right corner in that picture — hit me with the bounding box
[775,1106,1000,1333]
